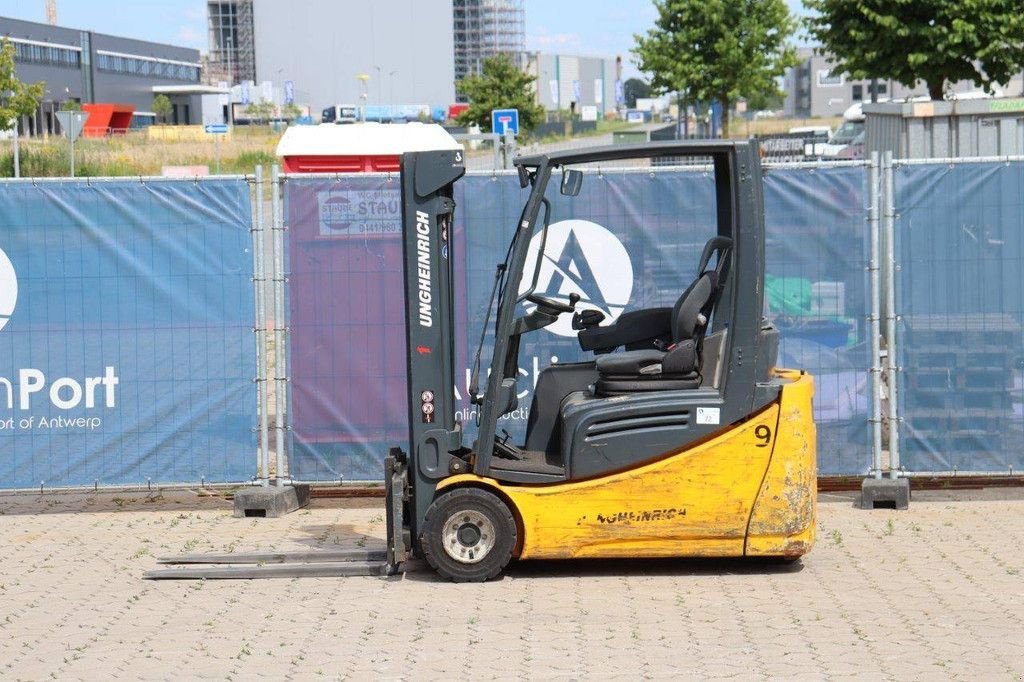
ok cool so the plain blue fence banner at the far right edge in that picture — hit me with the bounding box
[894,161,1024,472]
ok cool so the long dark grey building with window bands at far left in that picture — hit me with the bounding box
[0,16,203,135]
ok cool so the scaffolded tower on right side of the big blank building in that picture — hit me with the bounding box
[453,0,526,87]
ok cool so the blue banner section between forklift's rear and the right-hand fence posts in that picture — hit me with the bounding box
[765,166,874,474]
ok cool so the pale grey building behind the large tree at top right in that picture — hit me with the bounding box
[783,47,1021,119]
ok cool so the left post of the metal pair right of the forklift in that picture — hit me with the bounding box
[867,152,882,478]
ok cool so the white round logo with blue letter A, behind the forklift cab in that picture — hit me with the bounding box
[520,219,633,337]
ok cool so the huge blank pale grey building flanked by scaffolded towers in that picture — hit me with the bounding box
[207,0,525,112]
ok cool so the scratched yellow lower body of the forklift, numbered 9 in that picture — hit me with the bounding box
[438,373,816,559]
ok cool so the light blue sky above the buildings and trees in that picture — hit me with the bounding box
[0,0,803,78]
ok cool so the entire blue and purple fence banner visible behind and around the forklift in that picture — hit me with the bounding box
[285,167,871,480]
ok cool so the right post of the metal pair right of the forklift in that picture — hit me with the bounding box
[882,151,901,478]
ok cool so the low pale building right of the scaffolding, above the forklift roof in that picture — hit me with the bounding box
[525,52,623,118]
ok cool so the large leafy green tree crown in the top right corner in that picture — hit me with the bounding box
[804,0,1024,99]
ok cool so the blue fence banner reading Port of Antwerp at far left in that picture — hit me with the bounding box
[0,179,256,488]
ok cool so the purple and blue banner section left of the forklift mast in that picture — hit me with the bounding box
[284,175,407,480]
